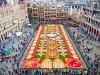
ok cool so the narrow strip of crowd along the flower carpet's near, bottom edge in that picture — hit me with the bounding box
[19,69,88,75]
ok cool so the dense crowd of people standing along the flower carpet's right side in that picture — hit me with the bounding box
[64,23,100,75]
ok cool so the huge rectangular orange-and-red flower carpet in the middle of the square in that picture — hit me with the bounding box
[21,24,84,69]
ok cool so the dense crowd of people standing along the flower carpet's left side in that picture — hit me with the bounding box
[0,24,34,75]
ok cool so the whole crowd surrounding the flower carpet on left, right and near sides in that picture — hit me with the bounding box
[0,22,100,75]
